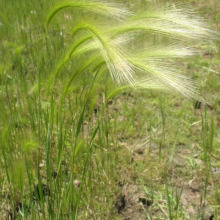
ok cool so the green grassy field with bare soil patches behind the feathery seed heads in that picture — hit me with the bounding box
[0,0,220,220]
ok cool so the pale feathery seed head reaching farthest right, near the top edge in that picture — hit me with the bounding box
[112,7,217,40]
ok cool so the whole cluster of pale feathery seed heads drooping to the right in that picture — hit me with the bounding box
[47,1,216,100]
